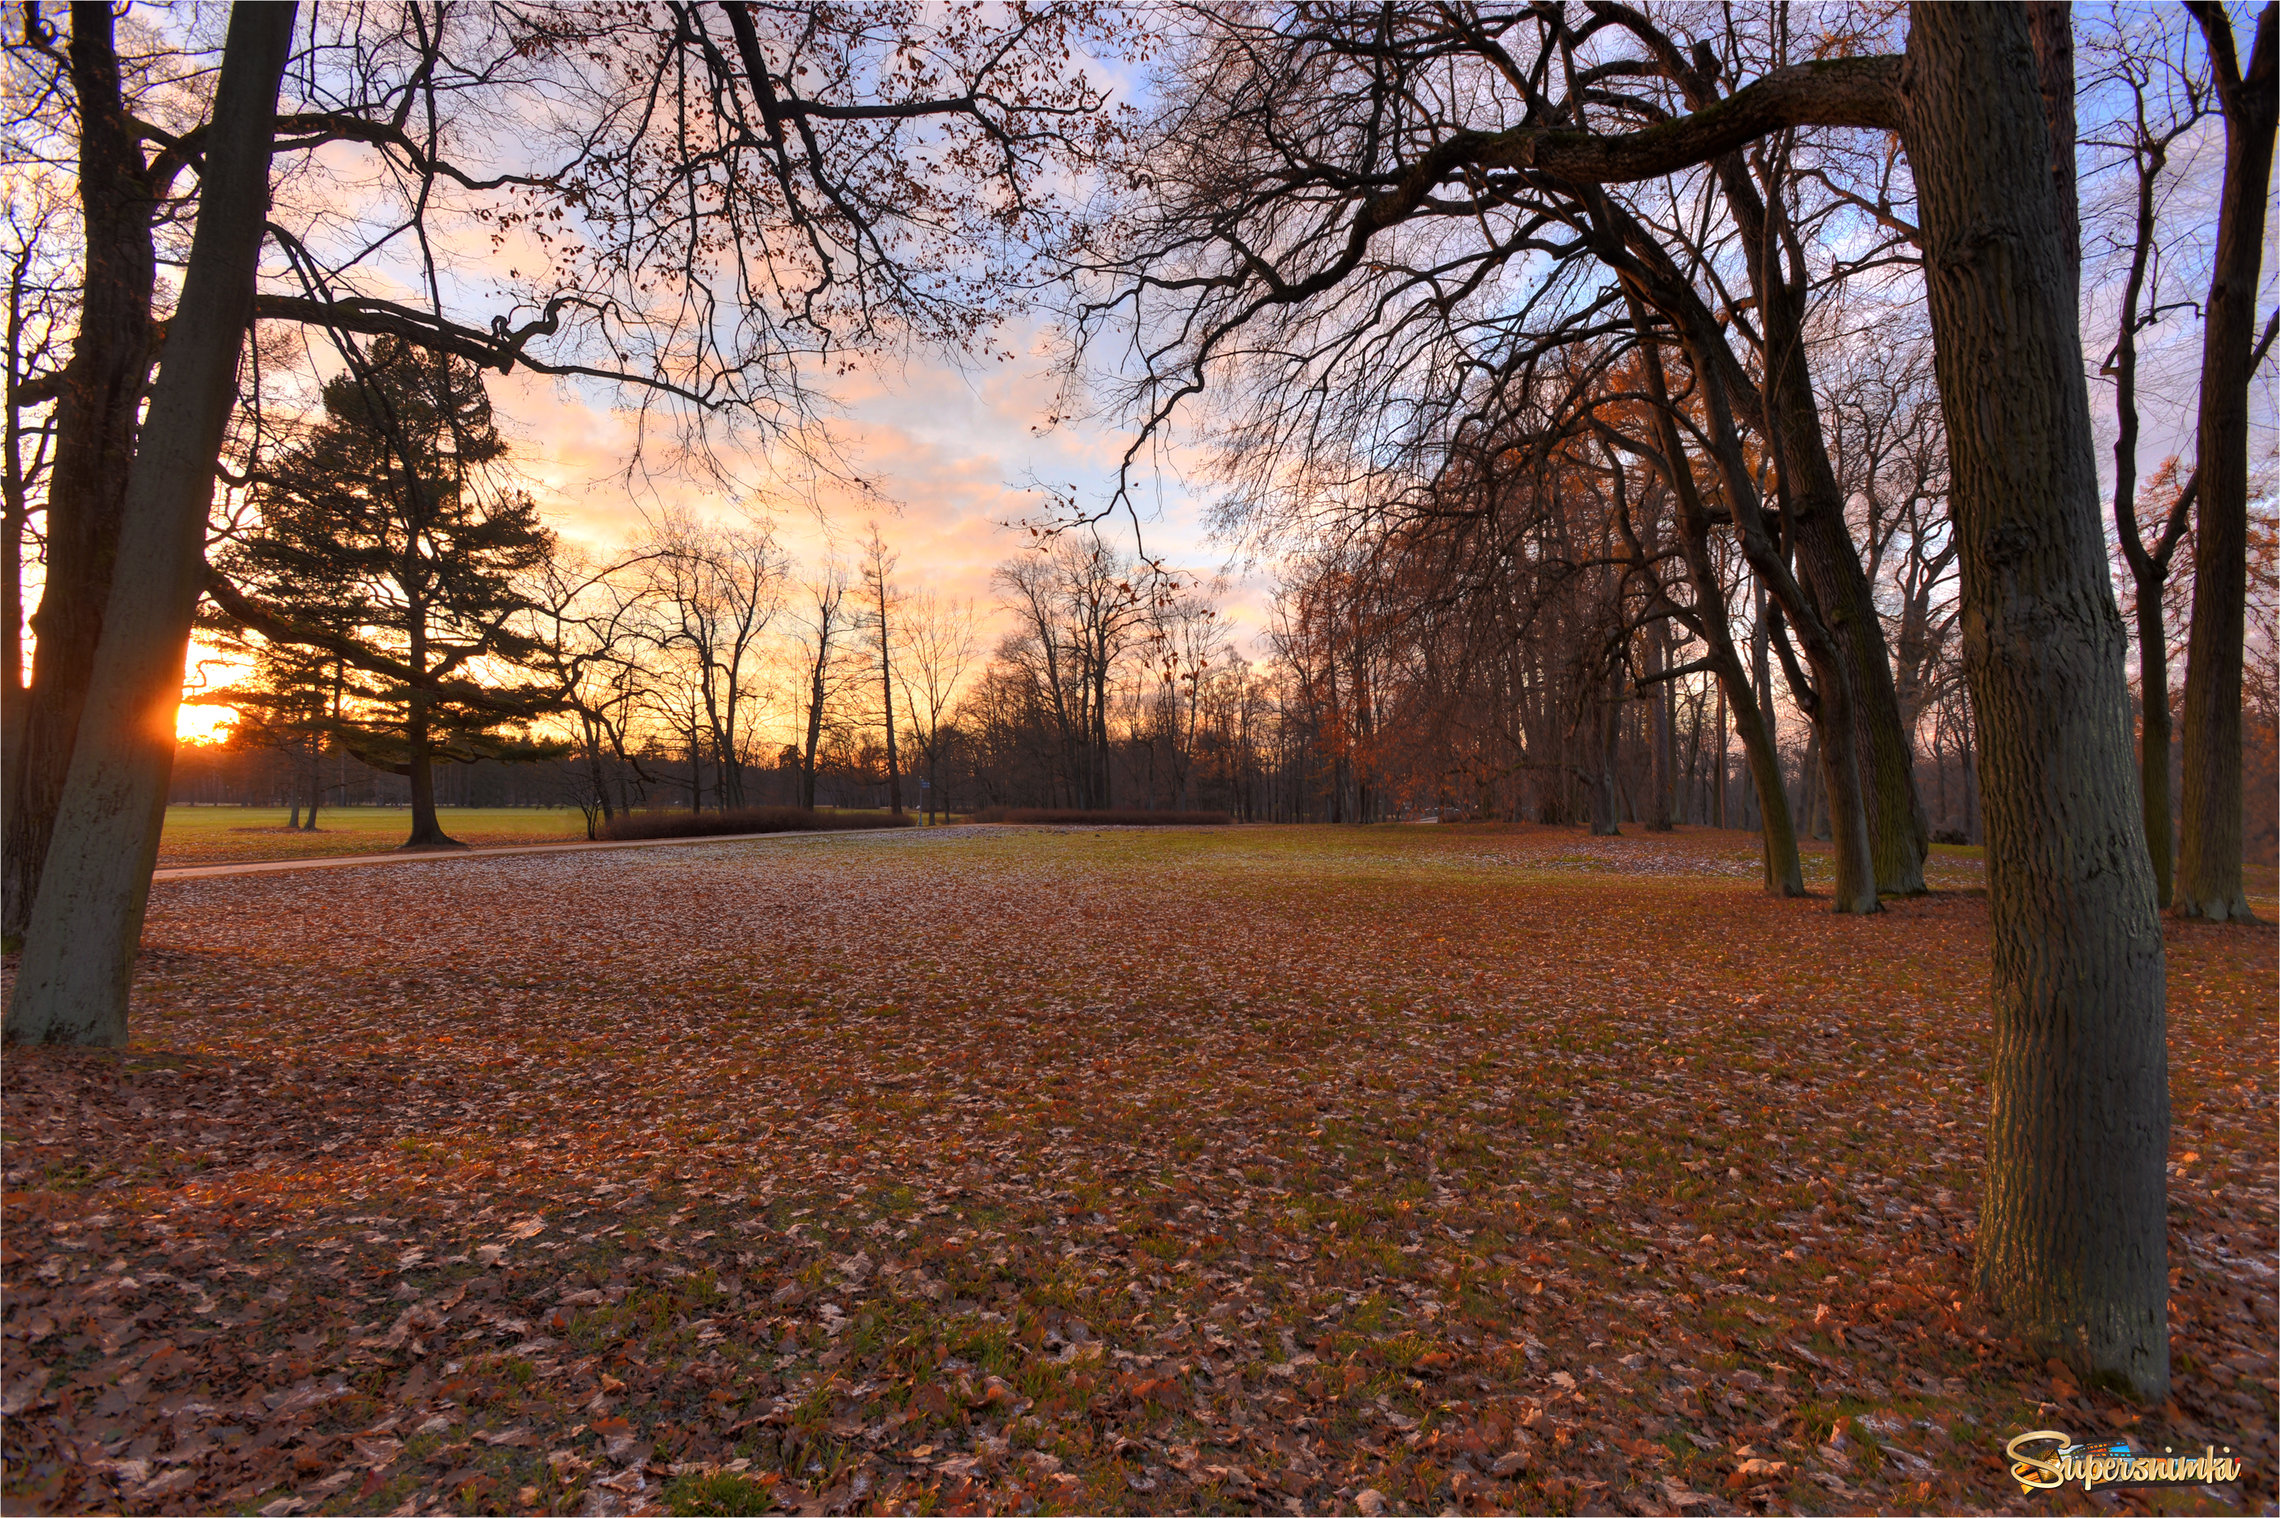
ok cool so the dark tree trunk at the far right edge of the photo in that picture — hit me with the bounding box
[2173,5,2280,923]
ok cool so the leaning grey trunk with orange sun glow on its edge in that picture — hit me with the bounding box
[7,5,294,1046]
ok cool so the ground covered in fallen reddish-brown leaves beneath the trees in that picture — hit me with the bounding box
[0,827,2280,1516]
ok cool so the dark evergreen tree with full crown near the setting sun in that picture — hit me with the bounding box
[217,340,559,848]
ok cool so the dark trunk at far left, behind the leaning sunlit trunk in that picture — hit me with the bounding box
[0,0,155,944]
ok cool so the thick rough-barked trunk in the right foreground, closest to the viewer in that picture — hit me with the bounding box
[1902,5,2168,1399]
